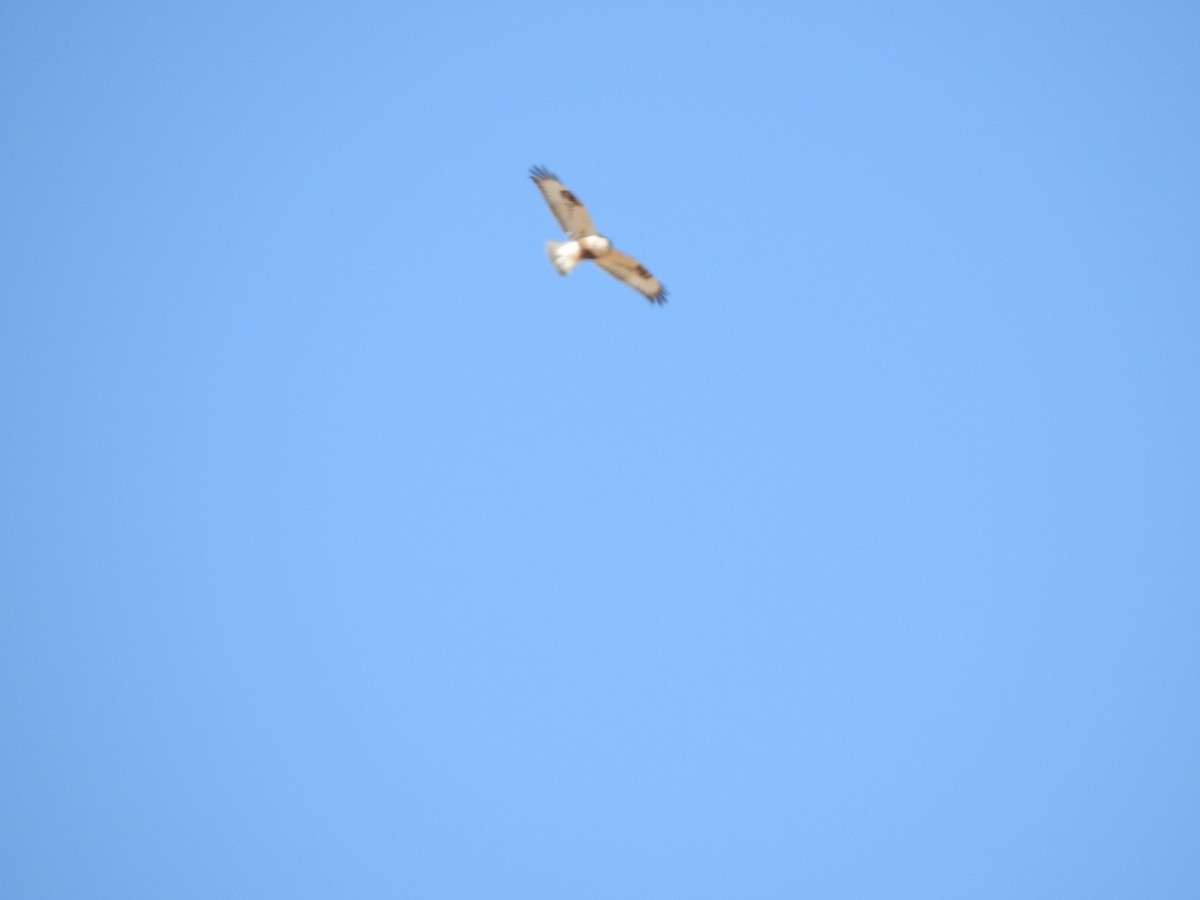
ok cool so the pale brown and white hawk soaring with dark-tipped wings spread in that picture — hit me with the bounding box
[529,166,667,304]
